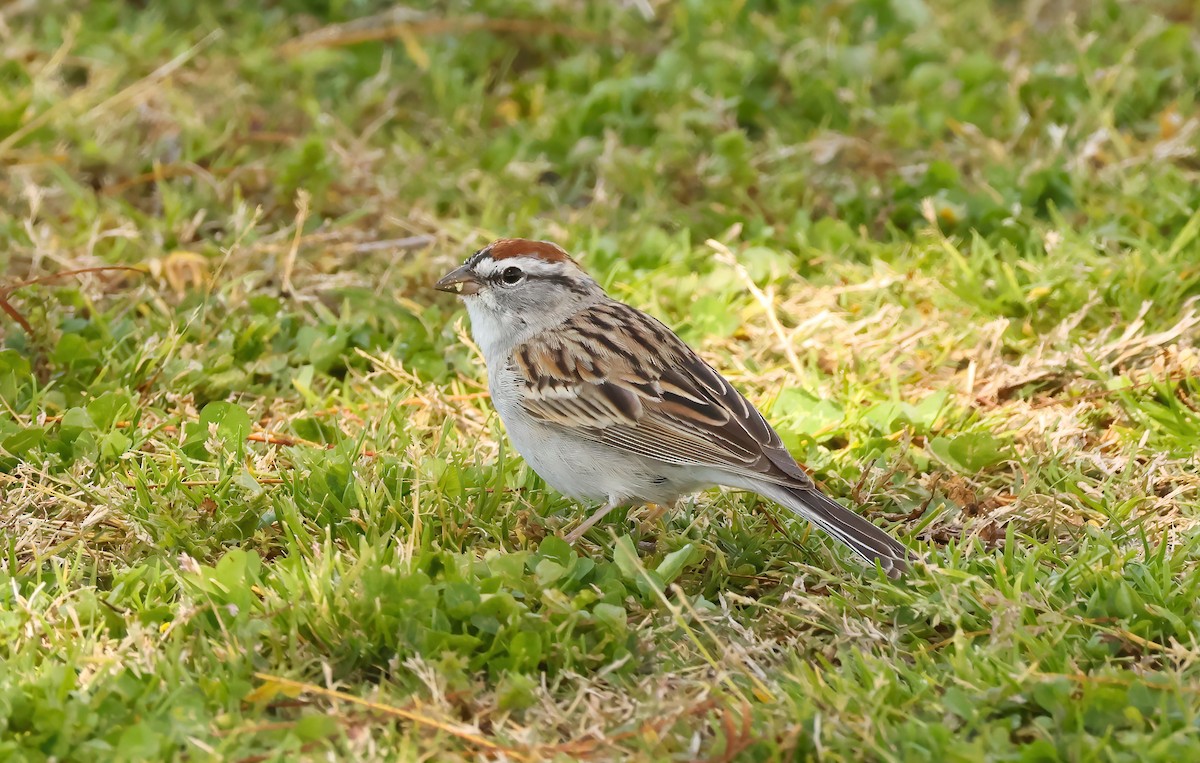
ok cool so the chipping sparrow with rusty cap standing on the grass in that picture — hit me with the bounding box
[436,239,913,577]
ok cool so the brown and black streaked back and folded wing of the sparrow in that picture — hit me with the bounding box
[512,301,812,488]
